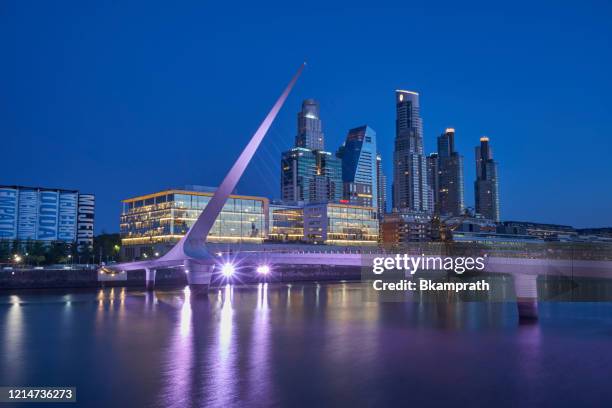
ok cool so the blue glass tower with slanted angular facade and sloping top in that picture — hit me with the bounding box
[336,125,378,207]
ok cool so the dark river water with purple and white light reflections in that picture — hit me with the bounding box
[0,283,612,407]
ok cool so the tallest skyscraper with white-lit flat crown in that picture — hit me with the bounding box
[393,90,432,212]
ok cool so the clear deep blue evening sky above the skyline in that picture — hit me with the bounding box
[0,0,612,233]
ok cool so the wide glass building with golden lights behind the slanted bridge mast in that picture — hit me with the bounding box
[120,186,269,259]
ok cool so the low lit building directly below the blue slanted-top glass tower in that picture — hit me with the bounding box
[304,203,378,245]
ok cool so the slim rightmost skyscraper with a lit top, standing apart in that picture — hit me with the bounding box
[474,136,499,221]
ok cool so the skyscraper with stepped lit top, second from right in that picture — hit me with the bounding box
[434,128,465,215]
